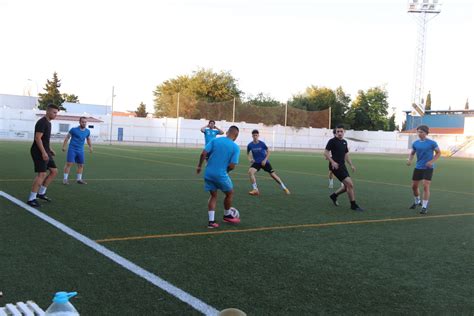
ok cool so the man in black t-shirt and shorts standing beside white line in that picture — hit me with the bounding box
[26,104,59,207]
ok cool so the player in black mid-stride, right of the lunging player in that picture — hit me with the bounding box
[324,125,363,211]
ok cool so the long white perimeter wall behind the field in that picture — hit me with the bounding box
[0,108,473,157]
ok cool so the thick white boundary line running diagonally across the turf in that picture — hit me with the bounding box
[0,191,219,315]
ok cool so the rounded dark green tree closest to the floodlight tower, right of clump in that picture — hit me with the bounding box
[348,87,388,131]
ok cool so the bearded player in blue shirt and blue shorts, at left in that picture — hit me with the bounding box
[63,116,92,184]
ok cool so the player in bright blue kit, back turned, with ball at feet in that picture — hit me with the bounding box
[196,126,240,228]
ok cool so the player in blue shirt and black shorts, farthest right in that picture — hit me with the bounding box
[407,125,441,214]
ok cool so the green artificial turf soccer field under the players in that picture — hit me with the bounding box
[0,142,474,315]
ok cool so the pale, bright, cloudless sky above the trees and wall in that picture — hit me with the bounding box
[0,0,474,121]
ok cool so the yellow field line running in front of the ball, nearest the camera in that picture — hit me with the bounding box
[96,213,474,243]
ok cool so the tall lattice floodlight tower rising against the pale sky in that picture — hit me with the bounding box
[408,0,441,115]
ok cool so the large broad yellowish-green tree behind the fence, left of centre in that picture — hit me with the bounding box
[153,68,242,118]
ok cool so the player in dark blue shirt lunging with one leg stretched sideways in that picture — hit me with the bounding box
[247,129,290,195]
